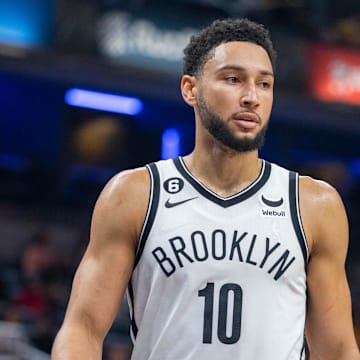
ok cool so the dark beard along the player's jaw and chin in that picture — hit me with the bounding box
[198,96,267,152]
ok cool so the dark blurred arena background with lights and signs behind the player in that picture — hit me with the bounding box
[0,0,360,360]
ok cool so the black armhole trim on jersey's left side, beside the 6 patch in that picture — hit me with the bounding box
[134,163,160,268]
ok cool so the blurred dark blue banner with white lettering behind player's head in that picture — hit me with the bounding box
[96,1,225,73]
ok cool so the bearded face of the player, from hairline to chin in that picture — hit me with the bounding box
[197,42,274,152]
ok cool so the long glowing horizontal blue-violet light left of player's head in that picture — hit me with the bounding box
[65,88,143,115]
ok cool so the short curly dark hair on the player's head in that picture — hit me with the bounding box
[183,18,276,76]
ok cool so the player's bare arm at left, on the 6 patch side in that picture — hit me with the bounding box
[51,168,149,360]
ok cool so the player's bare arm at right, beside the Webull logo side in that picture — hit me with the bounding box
[300,177,360,360]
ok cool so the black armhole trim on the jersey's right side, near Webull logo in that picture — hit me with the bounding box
[289,171,308,264]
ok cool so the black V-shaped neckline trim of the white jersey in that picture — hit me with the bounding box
[173,157,271,208]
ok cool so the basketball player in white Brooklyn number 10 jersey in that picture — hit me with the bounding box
[52,19,360,360]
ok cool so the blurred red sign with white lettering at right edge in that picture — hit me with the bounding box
[308,45,360,105]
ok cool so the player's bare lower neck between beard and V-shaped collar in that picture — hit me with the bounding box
[184,148,262,197]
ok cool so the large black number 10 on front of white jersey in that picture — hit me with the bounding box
[198,282,243,344]
